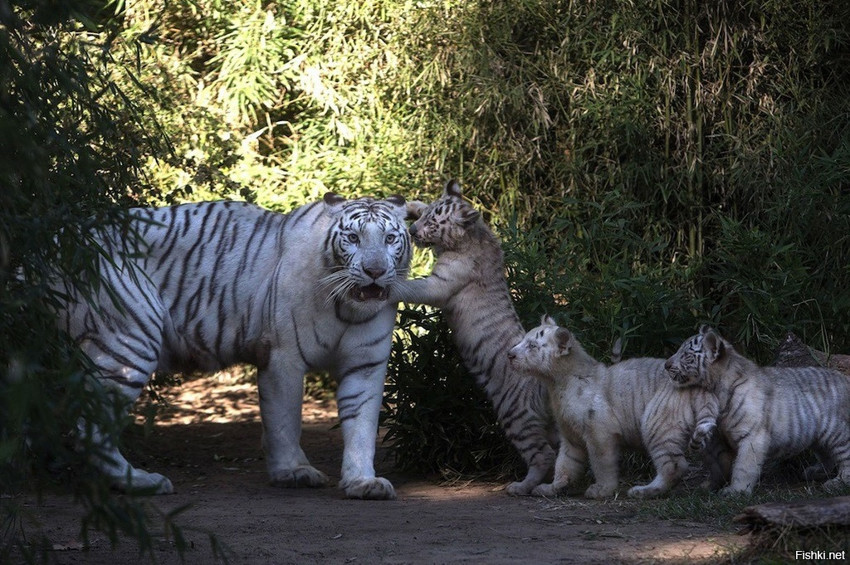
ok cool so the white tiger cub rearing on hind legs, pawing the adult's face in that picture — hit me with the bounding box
[397,180,555,495]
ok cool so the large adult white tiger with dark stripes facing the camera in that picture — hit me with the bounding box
[60,193,411,499]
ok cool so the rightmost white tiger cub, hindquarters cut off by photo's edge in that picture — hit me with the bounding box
[665,326,850,495]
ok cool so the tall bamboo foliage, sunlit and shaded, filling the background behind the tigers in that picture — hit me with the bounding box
[6,0,850,494]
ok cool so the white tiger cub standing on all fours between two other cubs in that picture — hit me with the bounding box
[508,316,717,498]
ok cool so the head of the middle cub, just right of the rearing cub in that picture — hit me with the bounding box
[508,316,578,378]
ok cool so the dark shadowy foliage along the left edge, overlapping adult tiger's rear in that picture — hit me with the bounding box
[0,1,194,561]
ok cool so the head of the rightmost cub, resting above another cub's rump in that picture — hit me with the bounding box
[664,326,732,387]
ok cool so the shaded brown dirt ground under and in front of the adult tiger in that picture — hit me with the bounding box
[14,374,746,565]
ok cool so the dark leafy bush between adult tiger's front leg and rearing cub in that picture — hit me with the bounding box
[383,306,521,479]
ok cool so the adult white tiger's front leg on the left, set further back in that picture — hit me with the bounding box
[257,351,328,488]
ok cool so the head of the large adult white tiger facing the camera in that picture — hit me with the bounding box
[321,193,410,310]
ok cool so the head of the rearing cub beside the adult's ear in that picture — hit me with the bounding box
[407,179,481,253]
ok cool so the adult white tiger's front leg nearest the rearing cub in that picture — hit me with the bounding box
[337,357,396,500]
